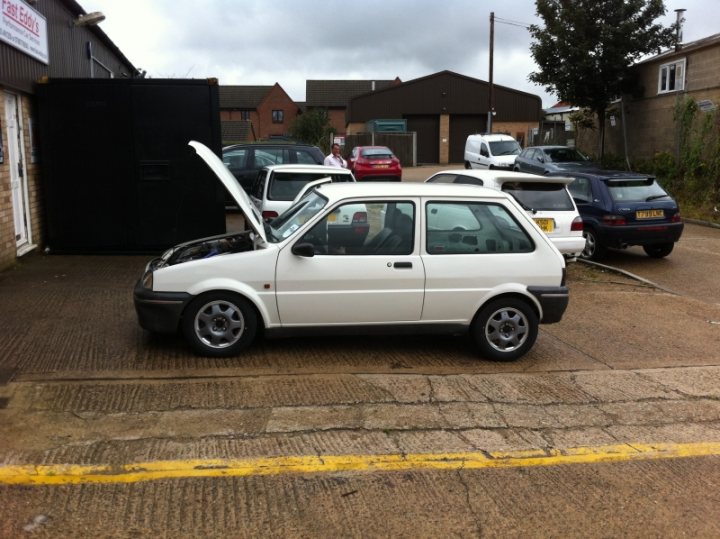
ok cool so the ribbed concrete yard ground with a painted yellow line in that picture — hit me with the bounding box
[0,210,720,538]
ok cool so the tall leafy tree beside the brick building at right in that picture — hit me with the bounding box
[528,0,677,157]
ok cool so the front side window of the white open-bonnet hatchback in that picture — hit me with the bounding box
[300,202,415,256]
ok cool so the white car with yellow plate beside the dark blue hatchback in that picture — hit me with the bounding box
[426,170,585,258]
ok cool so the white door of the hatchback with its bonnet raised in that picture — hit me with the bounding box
[275,200,425,327]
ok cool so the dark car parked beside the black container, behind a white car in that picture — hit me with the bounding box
[223,142,325,191]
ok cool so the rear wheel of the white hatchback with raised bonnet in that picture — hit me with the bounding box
[470,298,538,361]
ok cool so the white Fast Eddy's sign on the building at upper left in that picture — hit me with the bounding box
[0,0,49,64]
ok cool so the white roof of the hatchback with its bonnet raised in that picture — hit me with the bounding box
[316,182,510,200]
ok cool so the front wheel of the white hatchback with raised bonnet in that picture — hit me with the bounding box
[182,292,257,357]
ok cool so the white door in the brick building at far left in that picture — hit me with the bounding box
[5,92,30,254]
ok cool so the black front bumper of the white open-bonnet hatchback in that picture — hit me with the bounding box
[133,279,193,333]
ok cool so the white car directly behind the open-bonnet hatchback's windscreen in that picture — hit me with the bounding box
[250,165,355,220]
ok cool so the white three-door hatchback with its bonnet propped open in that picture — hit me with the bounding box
[134,141,569,360]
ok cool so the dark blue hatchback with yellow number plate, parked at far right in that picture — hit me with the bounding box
[553,169,684,260]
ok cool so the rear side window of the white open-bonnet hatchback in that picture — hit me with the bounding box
[426,202,534,255]
